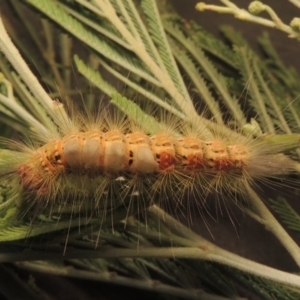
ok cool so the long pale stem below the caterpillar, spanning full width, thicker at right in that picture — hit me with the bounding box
[0,241,300,288]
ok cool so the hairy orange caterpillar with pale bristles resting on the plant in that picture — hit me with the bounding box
[4,98,296,227]
